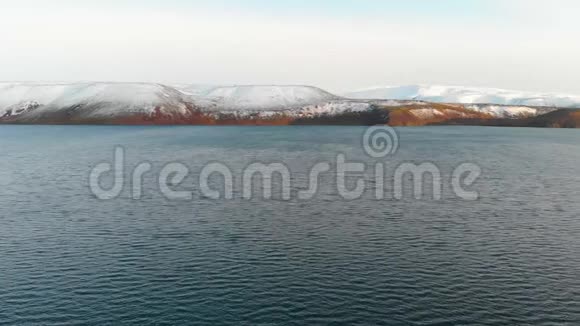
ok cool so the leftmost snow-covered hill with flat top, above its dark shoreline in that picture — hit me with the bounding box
[0,83,189,120]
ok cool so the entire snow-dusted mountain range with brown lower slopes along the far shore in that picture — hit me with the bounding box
[0,82,580,127]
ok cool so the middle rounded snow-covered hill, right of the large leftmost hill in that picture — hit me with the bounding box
[176,85,339,111]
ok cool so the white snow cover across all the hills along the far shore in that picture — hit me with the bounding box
[0,82,568,122]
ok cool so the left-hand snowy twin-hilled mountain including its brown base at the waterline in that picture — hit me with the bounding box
[0,82,371,124]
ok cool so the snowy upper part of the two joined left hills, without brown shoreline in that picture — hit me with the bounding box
[0,82,358,120]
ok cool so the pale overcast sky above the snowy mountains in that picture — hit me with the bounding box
[0,0,580,94]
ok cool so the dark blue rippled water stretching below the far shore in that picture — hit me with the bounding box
[0,126,580,325]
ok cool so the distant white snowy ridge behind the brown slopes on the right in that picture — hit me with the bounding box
[345,85,580,108]
